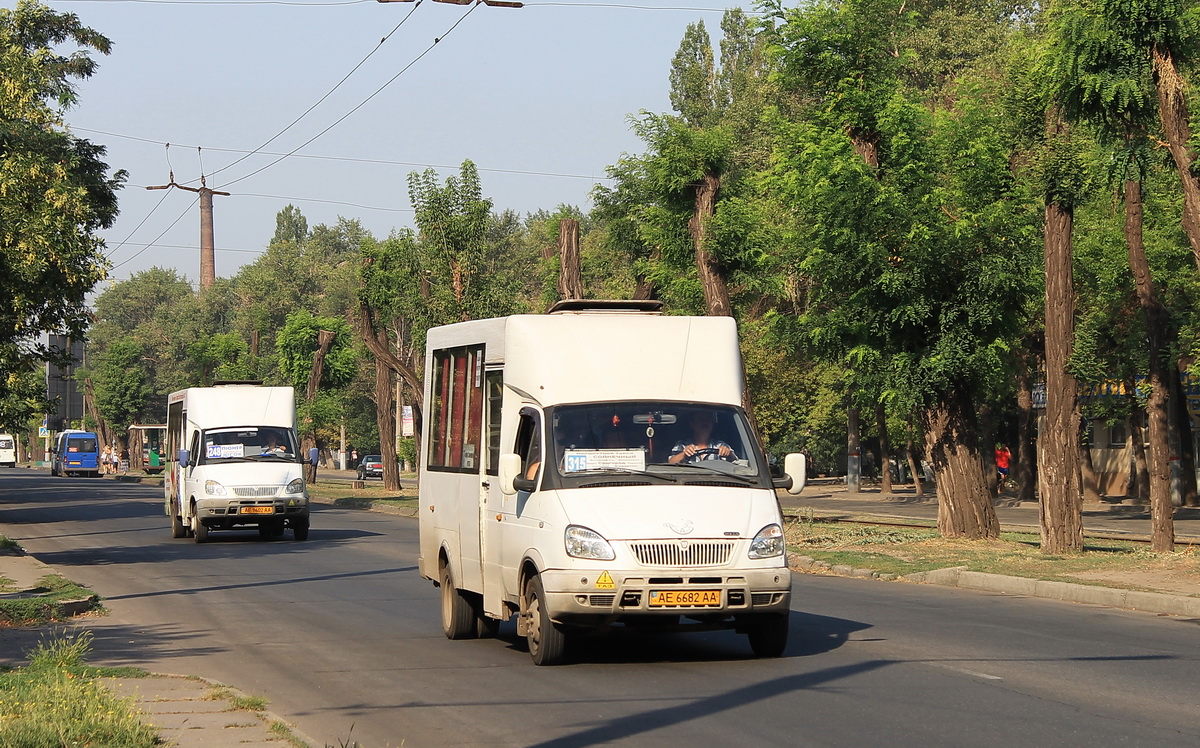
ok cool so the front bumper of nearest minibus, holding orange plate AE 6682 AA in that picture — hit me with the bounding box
[541,567,792,623]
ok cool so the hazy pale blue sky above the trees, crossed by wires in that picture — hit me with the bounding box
[21,0,752,291]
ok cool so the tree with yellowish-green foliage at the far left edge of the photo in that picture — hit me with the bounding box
[0,0,125,400]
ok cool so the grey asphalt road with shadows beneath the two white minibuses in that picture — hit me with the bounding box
[0,469,1200,748]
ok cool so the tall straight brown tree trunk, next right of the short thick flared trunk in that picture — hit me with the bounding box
[1038,202,1084,553]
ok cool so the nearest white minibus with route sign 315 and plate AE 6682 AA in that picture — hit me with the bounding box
[419,301,805,665]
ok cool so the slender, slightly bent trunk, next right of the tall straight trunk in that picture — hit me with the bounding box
[1124,179,1175,553]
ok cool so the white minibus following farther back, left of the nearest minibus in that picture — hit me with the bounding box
[163,382,317,543]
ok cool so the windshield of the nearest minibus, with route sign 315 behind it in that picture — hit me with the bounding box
[547,402,764,486]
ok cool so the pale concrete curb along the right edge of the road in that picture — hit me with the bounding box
[787,553,1200,618]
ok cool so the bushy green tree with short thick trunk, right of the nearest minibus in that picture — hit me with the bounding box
[768,0,1036,538]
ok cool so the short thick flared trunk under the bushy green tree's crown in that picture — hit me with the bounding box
[922,390,1000,539]
